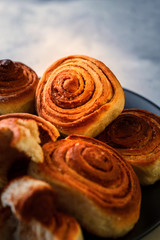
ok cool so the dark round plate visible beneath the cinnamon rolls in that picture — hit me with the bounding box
[84,89,160,240]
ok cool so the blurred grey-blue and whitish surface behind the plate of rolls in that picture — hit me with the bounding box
[0,0,160,240]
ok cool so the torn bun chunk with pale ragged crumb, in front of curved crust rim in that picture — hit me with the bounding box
[0,119,43,189]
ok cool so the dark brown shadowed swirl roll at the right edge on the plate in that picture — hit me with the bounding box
[97,109,160,185]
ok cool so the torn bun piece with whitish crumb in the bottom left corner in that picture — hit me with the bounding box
[2,176,83,240]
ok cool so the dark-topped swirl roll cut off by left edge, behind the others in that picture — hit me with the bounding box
[0,59,39,115]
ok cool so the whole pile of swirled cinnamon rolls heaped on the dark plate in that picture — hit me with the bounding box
[0,55,160,240]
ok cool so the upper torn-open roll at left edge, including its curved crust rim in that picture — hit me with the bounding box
[0,113,59,189]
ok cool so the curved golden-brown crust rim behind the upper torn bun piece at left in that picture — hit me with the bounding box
[0,113,60,145]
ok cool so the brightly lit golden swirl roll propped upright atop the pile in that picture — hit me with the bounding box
[36,55,124,137]
